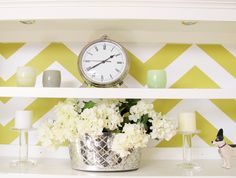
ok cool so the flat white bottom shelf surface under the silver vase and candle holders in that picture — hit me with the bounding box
[0,157,236,178]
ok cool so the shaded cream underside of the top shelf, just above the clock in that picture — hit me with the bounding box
[0,19,236,45]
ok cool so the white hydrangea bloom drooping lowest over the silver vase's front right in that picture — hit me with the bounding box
[112,124,149,157]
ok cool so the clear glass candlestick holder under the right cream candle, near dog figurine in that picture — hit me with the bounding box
[178,130,200,169]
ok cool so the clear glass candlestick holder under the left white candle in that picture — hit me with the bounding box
[11,128,36,167]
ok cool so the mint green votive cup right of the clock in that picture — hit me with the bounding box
[147,70,167,88]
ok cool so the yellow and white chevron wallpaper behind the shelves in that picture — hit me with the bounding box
[0,43,236,147]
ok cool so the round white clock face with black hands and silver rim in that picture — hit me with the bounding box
[79,41,128,85]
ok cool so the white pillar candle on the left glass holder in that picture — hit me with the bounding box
[15,111,33,129]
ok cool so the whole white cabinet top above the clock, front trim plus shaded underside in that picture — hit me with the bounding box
[0,0,236,44]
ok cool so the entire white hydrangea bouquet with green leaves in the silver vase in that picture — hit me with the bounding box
[39,99,176,157]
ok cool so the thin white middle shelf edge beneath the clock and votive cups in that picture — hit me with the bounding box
[0,87,236,99]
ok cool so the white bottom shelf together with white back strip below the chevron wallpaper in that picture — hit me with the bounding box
[0,145,236,178]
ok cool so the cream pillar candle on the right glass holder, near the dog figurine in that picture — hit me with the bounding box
[179,112,196,132]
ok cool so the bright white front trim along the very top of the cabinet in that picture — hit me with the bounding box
[0,0,236,21]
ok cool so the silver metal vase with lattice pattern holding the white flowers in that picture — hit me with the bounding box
[69,133,141,172]
